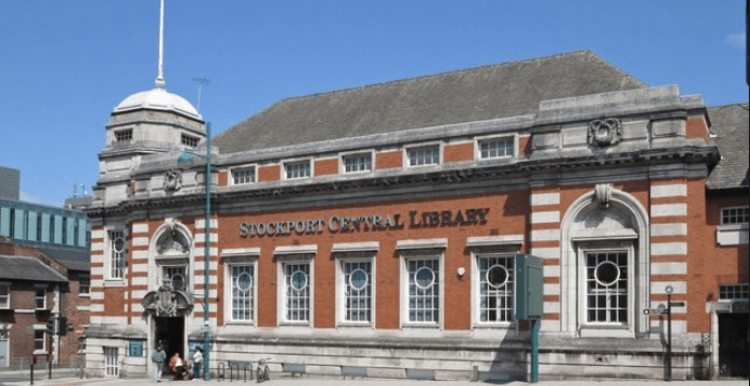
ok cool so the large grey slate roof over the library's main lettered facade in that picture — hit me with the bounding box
[214,51,647,154]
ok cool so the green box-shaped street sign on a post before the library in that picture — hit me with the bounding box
[515,253,544,383]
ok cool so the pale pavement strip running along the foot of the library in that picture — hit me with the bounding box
[0,371,748,386]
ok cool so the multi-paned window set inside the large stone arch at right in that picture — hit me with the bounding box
[586,251,630,324]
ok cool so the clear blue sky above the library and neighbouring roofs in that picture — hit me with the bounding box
[0,0,748,205]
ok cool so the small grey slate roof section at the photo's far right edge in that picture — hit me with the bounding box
[706,103,750,190]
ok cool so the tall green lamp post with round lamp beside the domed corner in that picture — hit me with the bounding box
[177,123,211,380]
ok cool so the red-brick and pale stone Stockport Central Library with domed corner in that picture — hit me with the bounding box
[85,51,750,381]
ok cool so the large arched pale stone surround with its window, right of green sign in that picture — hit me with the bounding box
[561,185,650,338]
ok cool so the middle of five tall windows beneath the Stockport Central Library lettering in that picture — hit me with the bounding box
[341,260,372,324]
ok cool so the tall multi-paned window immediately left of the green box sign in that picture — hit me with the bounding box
[477,254,515,323]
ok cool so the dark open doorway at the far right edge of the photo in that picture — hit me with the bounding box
[719,313,750,378]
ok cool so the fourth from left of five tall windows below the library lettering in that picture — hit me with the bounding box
[406,259,441,323]
